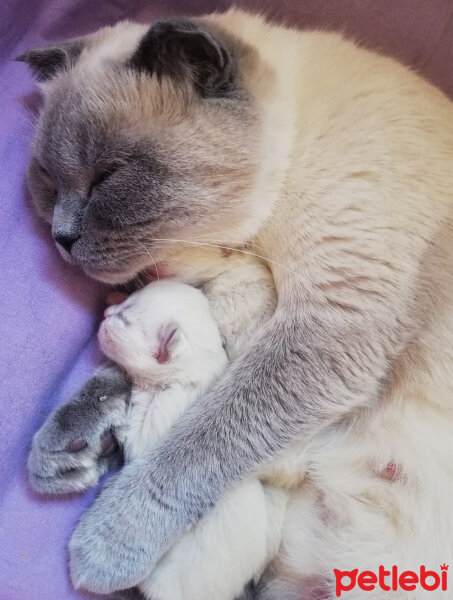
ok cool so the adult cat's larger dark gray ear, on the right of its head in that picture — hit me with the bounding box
[130,19,231,97]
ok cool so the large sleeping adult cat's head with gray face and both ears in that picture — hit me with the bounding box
[20,19,258,283]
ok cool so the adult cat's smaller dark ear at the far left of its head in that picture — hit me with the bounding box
[16,39,84,81]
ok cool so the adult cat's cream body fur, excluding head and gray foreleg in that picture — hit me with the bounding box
[150,11,453,600]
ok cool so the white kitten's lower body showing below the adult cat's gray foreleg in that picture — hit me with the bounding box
[139,479,288,600]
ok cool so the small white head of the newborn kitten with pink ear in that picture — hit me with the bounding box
[98,281,226,384]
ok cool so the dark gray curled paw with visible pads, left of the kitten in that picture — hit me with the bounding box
[28,365,130,494]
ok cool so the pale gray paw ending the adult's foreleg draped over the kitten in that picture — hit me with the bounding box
[69,461,164,594]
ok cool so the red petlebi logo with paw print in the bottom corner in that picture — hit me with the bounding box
[333,564,448,598]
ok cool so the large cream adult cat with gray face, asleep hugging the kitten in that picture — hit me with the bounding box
[22,11,453,600]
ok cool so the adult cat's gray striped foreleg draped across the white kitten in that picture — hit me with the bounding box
[70,314,340,593]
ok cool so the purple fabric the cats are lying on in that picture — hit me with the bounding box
[0,0,453,600]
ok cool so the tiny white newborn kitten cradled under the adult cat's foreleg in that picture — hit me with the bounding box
[99,281,286,600]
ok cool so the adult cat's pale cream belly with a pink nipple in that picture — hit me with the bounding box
[272,376,453,599]
